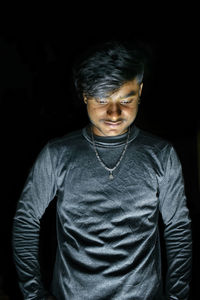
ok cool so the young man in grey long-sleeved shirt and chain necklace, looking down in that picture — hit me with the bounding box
[13,43,191,300]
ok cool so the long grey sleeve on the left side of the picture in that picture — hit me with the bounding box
[12,146,56,299]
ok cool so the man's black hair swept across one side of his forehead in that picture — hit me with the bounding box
[73,41,144,98]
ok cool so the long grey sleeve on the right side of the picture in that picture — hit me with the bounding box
[160,147,192,300]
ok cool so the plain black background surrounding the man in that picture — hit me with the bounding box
[0,3,200,300]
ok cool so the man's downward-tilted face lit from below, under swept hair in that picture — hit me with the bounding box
[84,79,143,136]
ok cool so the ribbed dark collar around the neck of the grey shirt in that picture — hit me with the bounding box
[82,124,139,147]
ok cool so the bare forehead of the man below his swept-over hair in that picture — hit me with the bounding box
[108,79,140,99]
